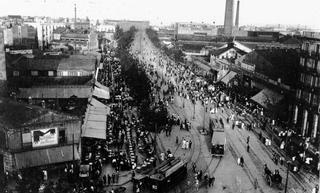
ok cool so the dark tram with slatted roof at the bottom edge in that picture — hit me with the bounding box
[147,158,187,193]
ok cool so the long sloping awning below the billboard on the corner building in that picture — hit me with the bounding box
[15,145,80,169]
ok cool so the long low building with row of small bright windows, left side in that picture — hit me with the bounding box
[6,54,98,88]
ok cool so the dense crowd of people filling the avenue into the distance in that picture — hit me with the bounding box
[133,30,319,191]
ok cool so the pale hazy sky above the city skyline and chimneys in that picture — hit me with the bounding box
[0,0,320,29]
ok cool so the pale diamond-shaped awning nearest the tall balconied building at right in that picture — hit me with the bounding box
[251,88,283,108]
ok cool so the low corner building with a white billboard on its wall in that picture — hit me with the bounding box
[0,98,81,173]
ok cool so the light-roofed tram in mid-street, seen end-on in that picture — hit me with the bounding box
[211,128,227,157]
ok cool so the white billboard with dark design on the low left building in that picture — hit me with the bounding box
[31,127,58,147]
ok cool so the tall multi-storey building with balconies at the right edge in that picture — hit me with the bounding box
[292,40,320,147]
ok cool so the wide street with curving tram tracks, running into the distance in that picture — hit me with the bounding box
[131,31,313,193]
